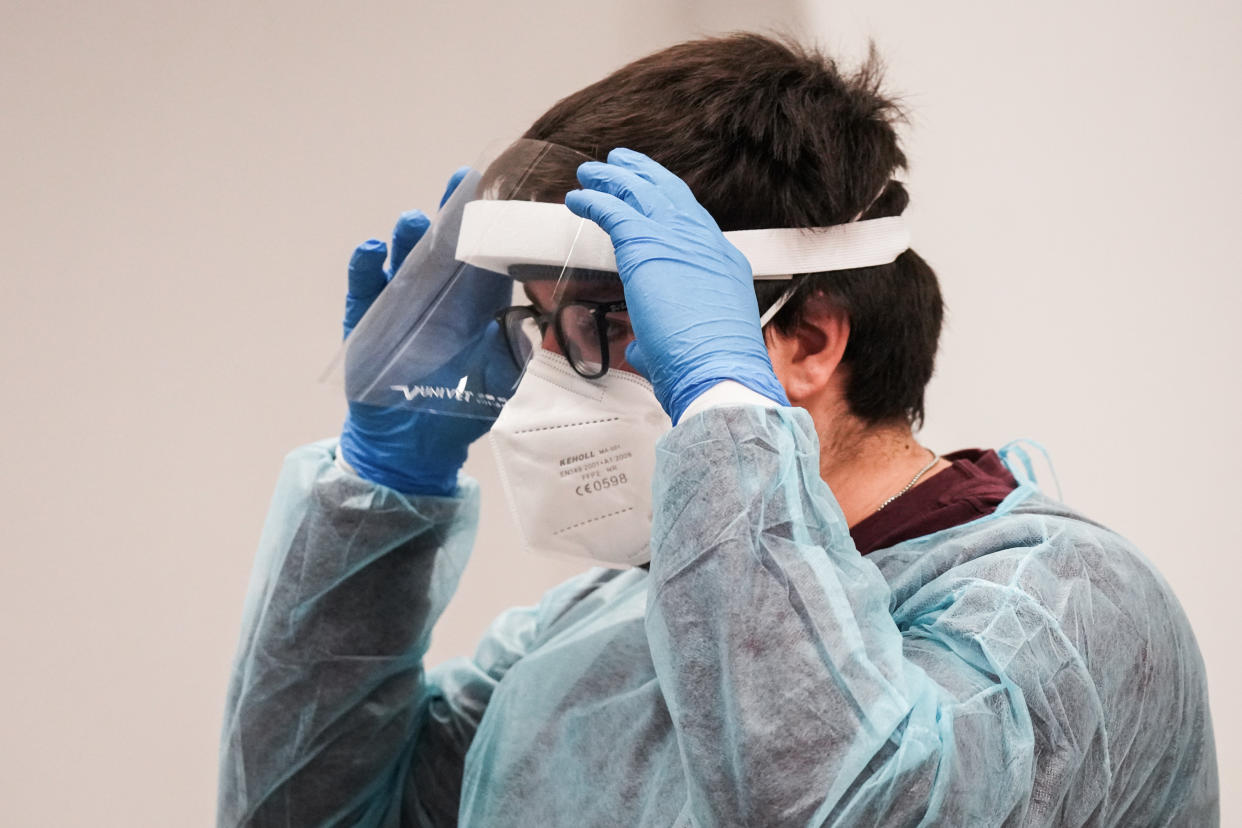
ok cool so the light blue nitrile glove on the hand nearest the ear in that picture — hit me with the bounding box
[565,149,789,423]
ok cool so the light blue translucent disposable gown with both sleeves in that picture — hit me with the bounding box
[219,406,1218,827]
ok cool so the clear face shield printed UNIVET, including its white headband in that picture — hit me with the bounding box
[333,139,909,422]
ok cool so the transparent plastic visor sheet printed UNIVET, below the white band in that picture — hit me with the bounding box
[330,139,603,421]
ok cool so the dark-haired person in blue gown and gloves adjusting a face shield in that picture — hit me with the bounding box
[219,35,1218,826]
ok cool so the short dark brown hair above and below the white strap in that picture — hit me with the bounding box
[524,34,944,425]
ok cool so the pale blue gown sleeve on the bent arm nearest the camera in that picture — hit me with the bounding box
[646,406,1109,827]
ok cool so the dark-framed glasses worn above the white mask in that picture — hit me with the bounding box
[496,299,633,380]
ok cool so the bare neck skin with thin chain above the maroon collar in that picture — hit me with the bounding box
[820,416,949,526]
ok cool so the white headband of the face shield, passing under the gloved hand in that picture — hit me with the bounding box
[457,200,910,279]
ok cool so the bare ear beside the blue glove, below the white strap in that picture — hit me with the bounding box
[764,295,850,405]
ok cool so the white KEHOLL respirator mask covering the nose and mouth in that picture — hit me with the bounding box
[491,350,673,569]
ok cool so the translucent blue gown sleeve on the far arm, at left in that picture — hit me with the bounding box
[217,442,534,826]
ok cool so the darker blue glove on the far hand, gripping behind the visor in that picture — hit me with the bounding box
[339,168,512,495]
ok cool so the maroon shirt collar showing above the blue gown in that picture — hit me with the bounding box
[850,448,1017,555]
